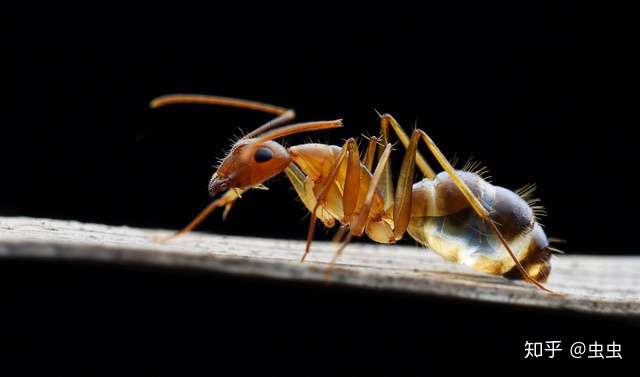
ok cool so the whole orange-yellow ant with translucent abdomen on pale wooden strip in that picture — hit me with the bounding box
[151,94,556,292]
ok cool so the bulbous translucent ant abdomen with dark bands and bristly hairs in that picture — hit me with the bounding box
[408,171,551,282]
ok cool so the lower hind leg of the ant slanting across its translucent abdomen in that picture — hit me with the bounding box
[414,130,553,293]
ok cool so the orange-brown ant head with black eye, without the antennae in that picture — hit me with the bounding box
[209,139,291,196]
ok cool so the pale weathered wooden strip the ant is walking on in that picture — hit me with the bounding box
[0,217,640,319]
